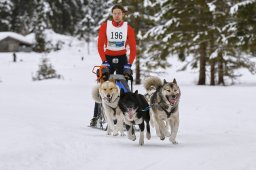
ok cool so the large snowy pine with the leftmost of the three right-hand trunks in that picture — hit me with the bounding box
[148,0,212,85]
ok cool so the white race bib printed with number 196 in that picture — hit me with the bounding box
[107,21,128,51]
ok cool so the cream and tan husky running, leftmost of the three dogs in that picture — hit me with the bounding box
[92,79,124,136]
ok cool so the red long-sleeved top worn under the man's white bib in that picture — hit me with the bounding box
[98,21,136,64]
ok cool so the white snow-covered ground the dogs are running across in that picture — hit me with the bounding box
[0,37,256,170]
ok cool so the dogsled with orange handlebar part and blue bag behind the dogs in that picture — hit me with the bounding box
[89,66,133,131]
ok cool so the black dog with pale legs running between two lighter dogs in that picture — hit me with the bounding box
[118,90,151,145]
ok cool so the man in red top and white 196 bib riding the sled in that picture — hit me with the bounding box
[90,5,136,126]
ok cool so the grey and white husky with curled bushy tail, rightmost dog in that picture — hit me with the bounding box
[143,77,181,144]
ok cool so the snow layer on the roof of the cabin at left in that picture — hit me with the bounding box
[0,32,33,45]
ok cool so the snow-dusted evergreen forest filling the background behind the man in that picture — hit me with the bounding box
[0,0,256,85]
